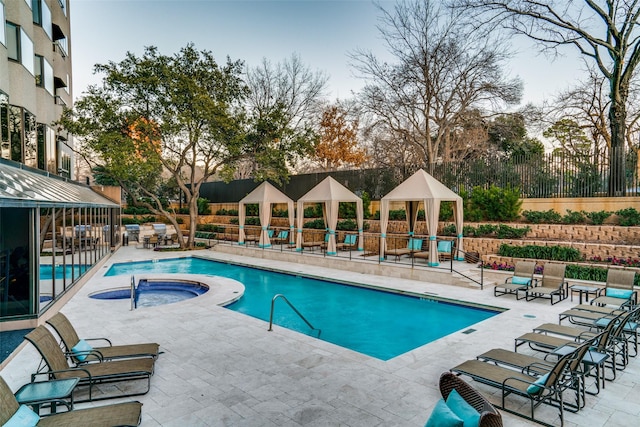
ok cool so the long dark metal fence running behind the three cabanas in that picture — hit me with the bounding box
[200,151,640,203]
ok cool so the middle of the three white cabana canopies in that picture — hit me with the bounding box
[296,176,364,255]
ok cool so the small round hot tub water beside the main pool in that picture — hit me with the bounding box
[89,279,209,307]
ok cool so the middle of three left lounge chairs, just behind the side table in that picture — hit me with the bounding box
[24,325,155,401]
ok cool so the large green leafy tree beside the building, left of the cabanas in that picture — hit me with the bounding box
[61,45,294,247]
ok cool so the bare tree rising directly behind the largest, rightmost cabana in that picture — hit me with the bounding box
[350,0,522,172]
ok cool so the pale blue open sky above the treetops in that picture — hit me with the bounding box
[70,0,584,103]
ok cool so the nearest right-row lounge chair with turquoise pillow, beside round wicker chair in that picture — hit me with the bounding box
[451,346,574,426]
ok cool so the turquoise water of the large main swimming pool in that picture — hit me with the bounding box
[106,258,499,360]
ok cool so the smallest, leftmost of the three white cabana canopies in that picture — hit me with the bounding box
[238,181,294,248]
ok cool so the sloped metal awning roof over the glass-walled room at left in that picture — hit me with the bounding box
[0,161,120,208]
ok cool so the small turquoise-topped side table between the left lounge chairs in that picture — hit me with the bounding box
[15,378,80,414]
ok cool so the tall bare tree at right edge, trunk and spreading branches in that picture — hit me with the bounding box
[454,0,640,196]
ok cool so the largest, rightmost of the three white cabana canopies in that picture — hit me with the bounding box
[380,169,463,266]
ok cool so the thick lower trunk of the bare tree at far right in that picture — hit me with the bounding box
[609,99,627,197]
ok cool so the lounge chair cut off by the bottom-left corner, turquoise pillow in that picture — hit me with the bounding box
[0,377,142,427]
